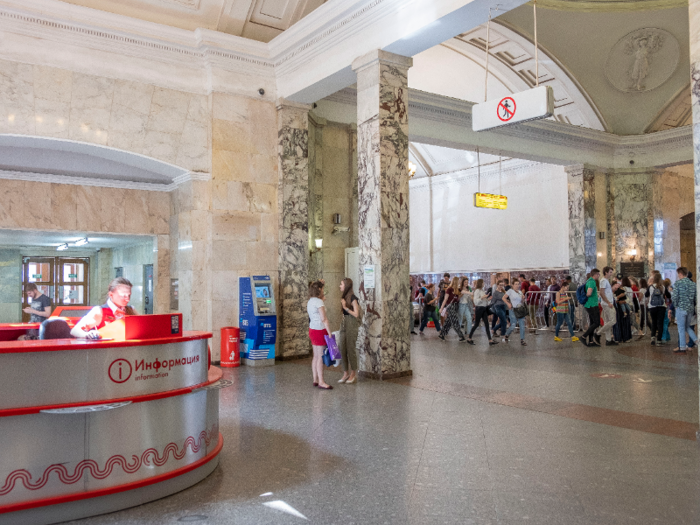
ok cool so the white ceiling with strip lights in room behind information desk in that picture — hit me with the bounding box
[0,229,153,249]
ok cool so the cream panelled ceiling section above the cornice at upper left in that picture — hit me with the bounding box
[55,0,326,42]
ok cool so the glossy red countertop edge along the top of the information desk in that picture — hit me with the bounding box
[0,332,213,354]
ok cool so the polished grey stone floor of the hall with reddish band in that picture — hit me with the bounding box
[74,331,700,525]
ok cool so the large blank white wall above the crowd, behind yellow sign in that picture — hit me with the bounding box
[410,160,569,273]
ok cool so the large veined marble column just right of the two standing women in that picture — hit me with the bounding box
[352,50,413,379]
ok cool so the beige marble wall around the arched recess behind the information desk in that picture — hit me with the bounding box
[0,60,279,359]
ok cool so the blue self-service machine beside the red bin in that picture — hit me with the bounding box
[238,275,277,366]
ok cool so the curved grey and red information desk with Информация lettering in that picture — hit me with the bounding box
[0,332,223,525]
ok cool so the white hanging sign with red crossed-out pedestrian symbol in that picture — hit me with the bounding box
[472,86,554,131]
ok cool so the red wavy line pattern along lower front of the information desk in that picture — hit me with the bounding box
[0,425,219,496]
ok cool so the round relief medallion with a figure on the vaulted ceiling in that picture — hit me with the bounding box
[605,27,680,93]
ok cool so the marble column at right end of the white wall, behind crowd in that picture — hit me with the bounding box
[566,165,597,283]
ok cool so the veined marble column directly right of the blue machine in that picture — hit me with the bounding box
[277,100,311,358]
